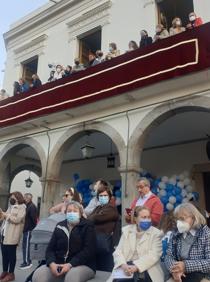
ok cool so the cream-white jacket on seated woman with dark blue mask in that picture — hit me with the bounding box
[107,225,164,282]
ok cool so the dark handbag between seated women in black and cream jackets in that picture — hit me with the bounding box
[96,233,113,254]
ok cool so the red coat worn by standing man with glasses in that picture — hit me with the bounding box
[131,194,163,226]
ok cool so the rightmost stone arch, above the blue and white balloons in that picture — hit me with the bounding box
[129,97,210,165]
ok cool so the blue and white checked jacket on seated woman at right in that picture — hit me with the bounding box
[165,225,210,277]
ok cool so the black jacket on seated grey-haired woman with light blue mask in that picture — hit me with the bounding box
[46,218,96,271]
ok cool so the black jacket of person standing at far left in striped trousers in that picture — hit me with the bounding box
[23,202,37,232]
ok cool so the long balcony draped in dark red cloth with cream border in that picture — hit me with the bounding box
[0,23,210,135]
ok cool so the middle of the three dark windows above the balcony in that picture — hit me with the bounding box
[78,28,101,64]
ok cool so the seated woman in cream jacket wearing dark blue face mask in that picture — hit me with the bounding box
[107,206,164,282]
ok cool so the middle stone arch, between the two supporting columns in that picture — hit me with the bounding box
[48,122,126,180]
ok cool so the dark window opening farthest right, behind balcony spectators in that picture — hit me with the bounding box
[156,0,194,29]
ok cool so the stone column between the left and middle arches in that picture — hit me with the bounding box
[40,178,60,217]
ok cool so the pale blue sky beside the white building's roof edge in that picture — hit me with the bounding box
[0,0,49,89]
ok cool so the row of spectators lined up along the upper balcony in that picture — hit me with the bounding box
[0,12,203,100]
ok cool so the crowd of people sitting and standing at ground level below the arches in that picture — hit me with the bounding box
[0,178,210,282]
